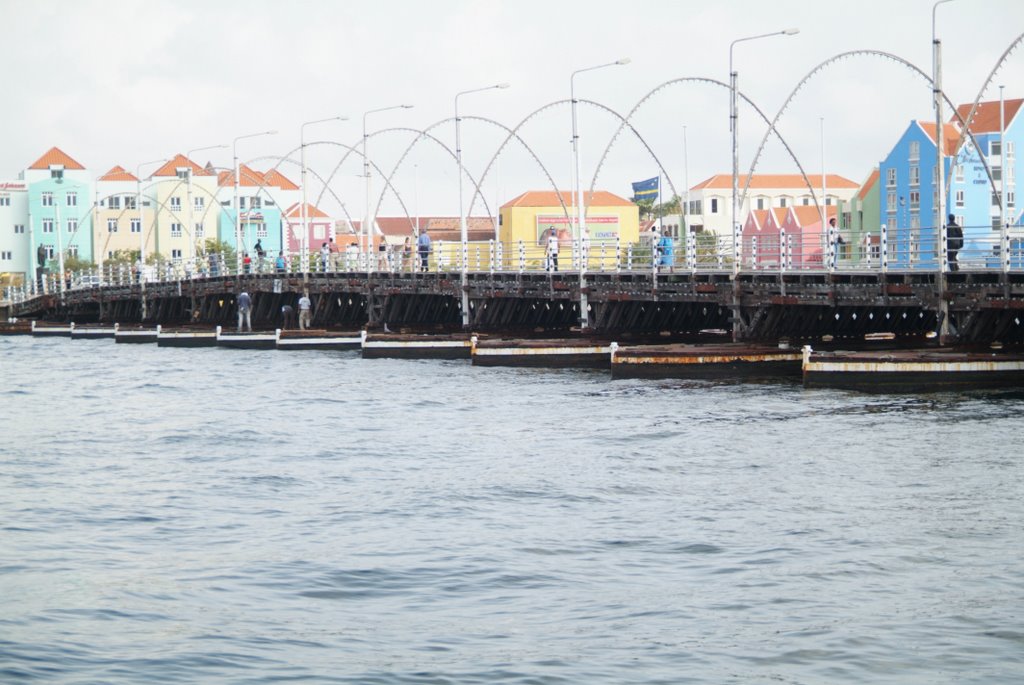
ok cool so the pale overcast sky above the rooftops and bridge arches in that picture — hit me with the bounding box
[0,0,1024,216]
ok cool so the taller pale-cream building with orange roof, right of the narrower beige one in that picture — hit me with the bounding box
[145,154,220,264]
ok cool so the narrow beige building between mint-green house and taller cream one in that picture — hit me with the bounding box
[92,166,142,266]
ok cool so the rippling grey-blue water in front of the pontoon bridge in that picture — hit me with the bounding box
[0,337,1024,684]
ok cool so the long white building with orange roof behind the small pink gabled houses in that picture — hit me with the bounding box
[686,173,859,237]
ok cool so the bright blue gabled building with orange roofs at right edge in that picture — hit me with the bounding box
[879,99,1024,269]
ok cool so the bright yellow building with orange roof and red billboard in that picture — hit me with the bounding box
[498,190,640,268]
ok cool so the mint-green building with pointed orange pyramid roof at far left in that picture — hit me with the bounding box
[20,147,93,270]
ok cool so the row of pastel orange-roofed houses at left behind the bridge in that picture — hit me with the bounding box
[0,147,335,285]
